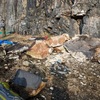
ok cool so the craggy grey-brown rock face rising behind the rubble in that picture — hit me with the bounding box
[0,0,100,37]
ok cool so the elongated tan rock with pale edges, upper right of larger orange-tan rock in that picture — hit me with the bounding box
[46,34,70,47]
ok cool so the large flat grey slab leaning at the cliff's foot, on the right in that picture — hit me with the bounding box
[64,36,100,59]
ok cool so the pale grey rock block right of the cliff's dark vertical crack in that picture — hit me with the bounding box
[82,5,100,38]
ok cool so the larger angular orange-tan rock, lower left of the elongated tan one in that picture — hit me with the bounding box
[27,41,52,59]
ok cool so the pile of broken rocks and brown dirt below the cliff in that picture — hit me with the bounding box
[0,34,100,100]
